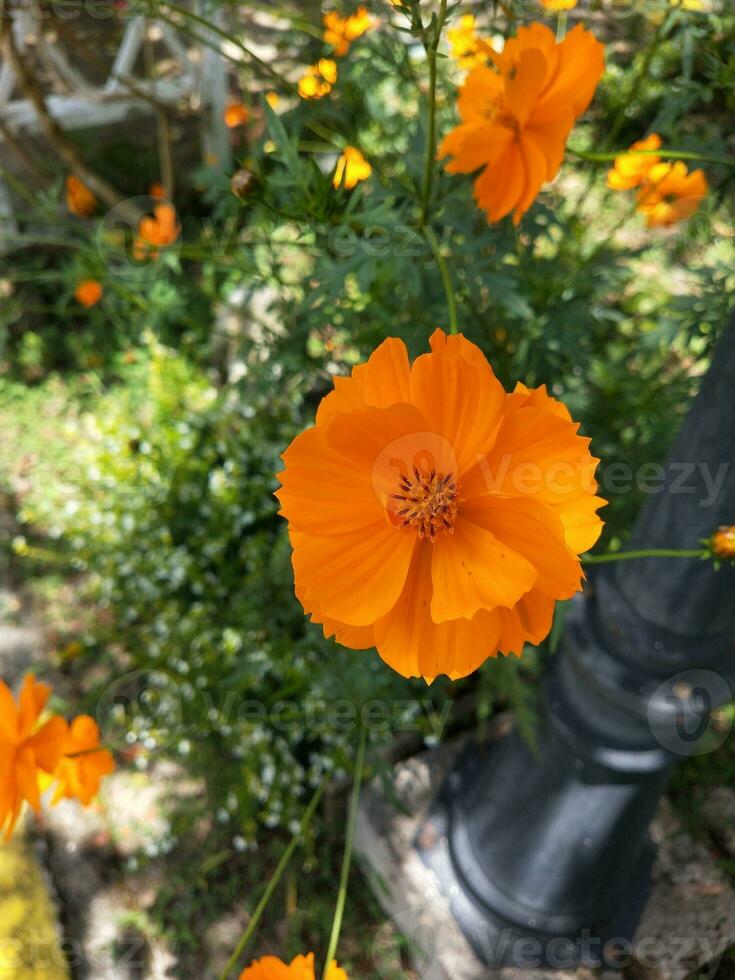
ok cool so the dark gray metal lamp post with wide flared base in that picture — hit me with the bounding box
[417,318,735,966]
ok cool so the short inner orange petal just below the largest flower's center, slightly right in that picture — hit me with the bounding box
[431,511,538,623]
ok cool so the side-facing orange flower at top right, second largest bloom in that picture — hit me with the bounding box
[439,23,604,224]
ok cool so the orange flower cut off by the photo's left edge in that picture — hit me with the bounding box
[0,674,68,840]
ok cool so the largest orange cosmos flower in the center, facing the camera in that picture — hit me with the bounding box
[277,330,604,680]
